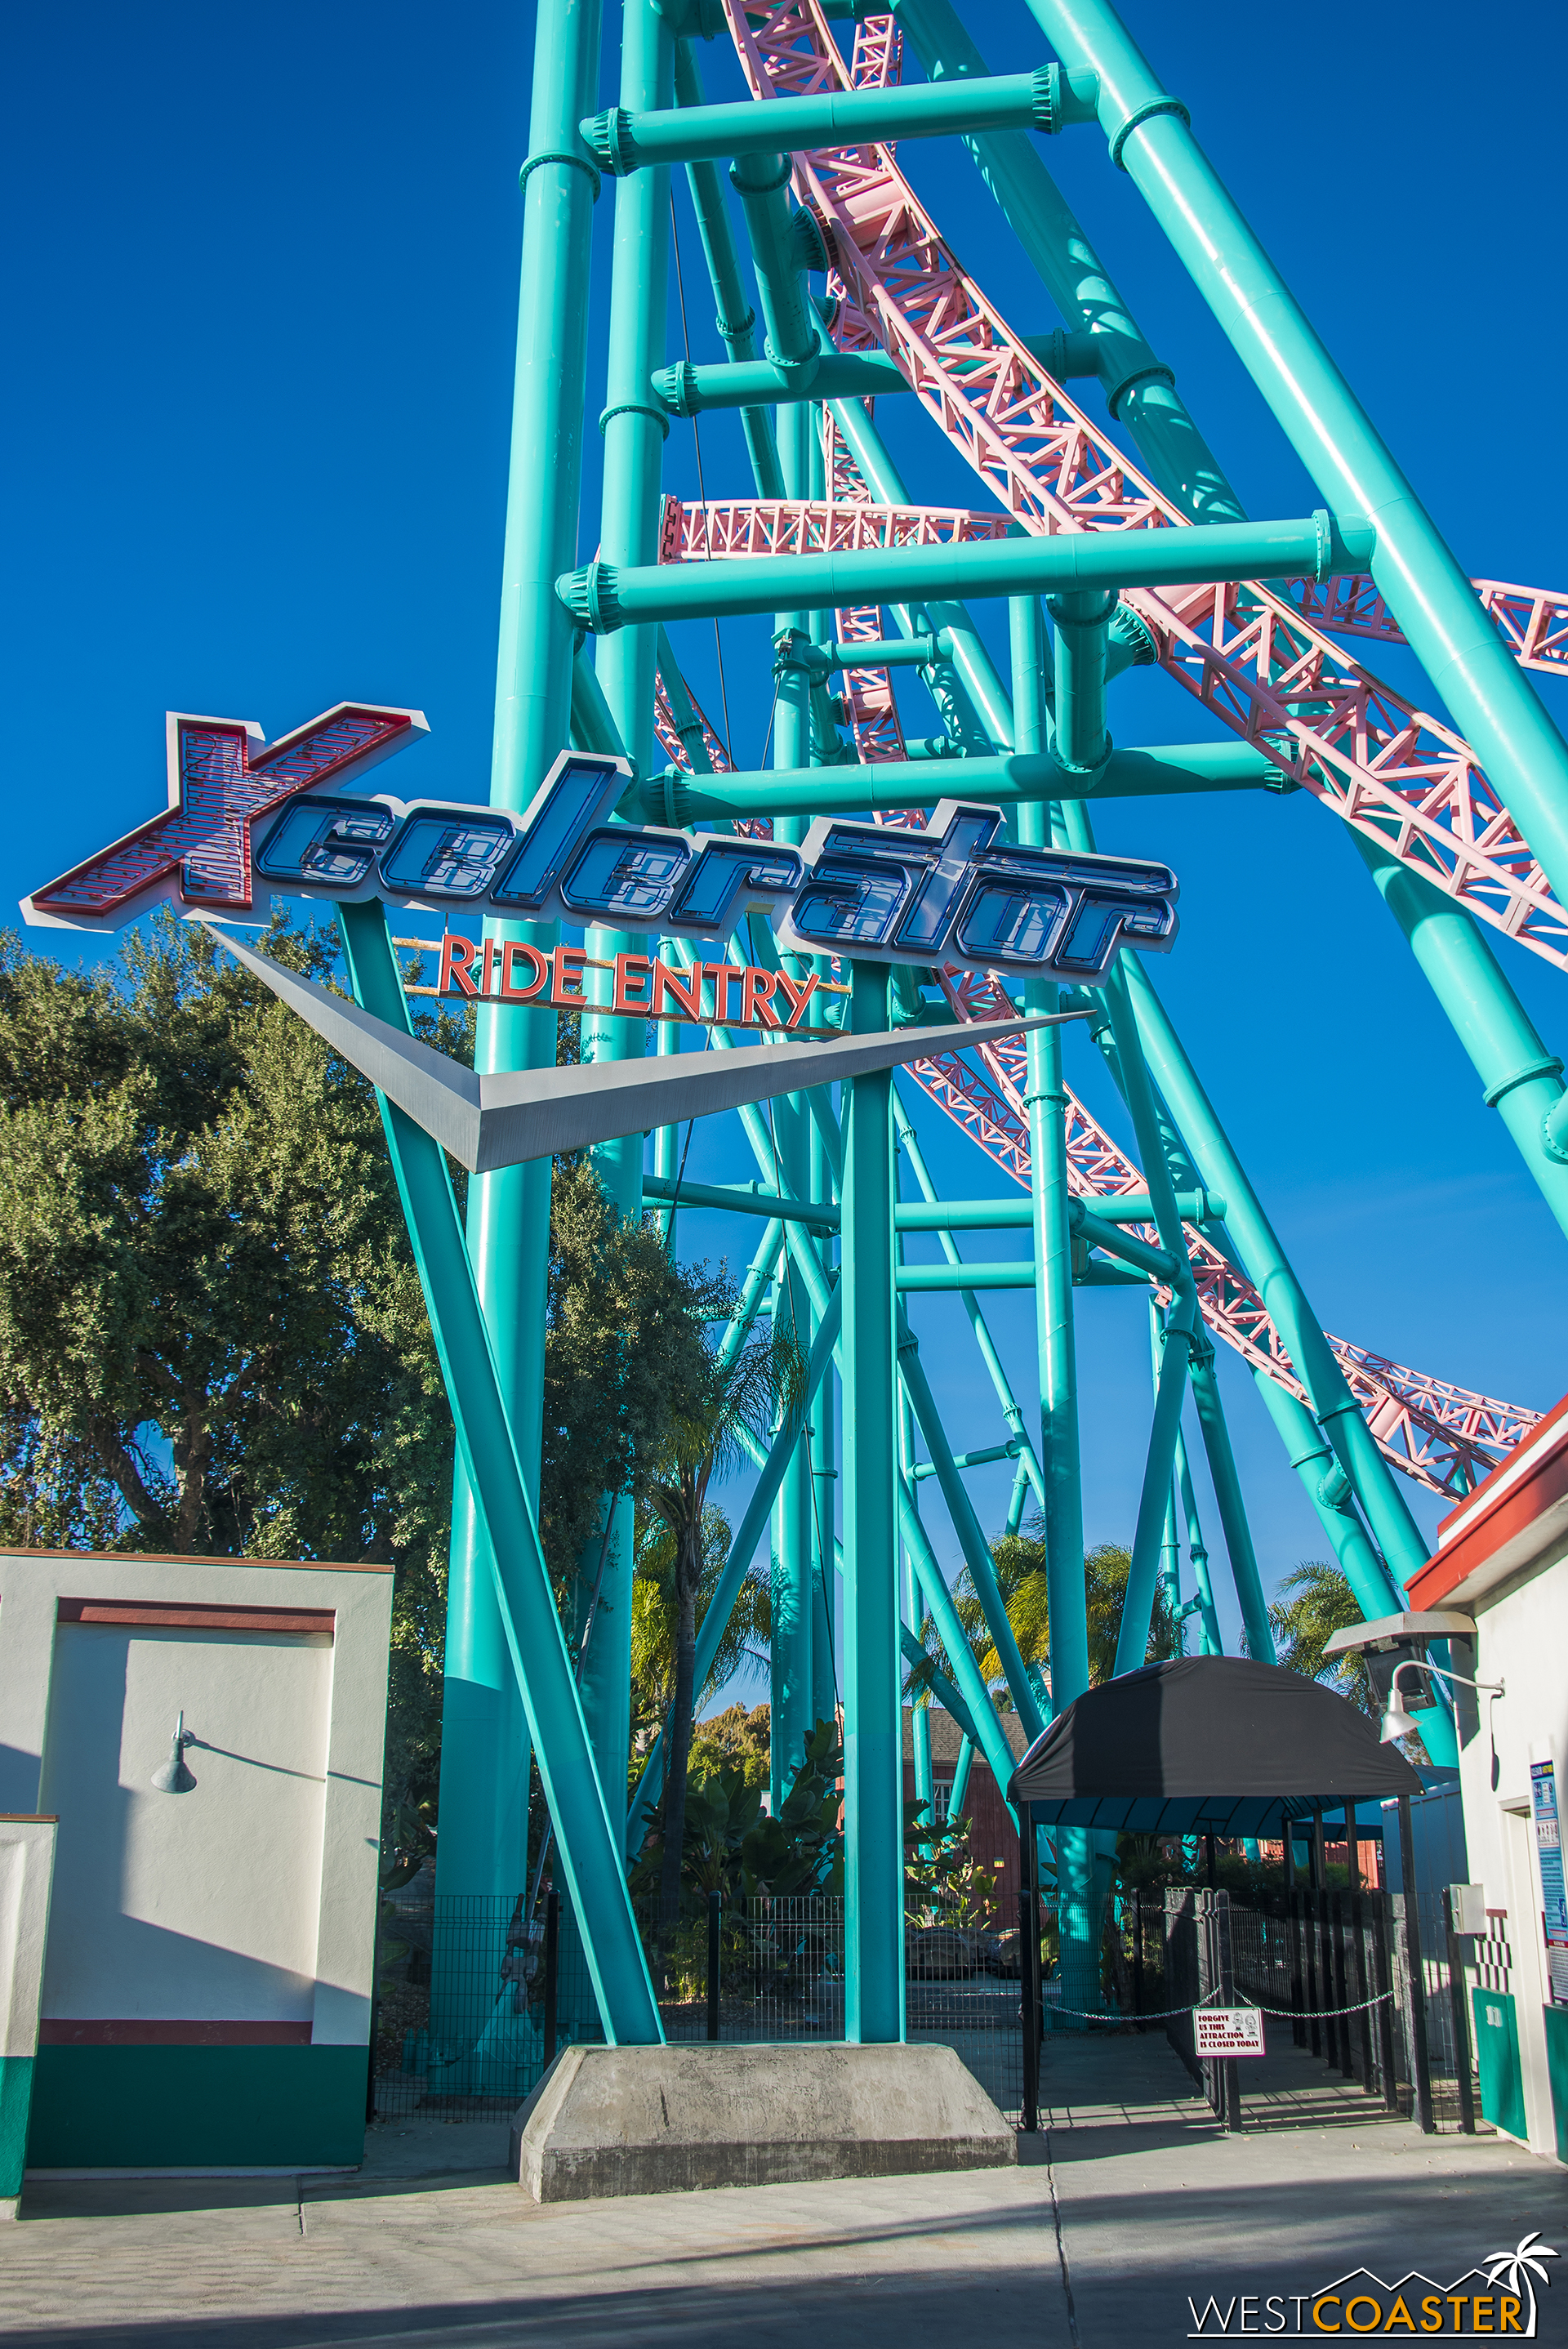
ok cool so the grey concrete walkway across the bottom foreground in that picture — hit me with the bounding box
[0,2035,1568,2349]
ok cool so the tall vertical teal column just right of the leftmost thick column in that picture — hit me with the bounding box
[577,0,674,1802]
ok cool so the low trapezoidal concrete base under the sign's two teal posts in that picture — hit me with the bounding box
[512,2046,1018,2201]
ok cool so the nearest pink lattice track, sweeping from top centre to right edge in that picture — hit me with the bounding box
[709,0,1568,965]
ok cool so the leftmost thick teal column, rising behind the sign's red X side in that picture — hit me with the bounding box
[439,0,599,1896]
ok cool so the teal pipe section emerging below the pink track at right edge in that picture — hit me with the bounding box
[1348,824,1568,1233]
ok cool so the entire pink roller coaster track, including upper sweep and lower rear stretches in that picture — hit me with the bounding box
[657,0,1568,1496]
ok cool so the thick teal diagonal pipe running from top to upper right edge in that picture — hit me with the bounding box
[1031,0,1568,925]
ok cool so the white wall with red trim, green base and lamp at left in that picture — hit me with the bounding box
[0,1550,392,2170]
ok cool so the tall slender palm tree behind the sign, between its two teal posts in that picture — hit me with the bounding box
[645,1306,805,1923]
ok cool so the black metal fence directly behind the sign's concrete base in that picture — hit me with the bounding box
[368,1879,1023,2121]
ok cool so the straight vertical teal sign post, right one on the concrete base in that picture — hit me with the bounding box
[838,963,904,2044]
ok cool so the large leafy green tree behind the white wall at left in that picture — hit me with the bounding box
[0,916,462,1807]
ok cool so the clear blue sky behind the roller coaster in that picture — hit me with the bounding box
[0,0,1568,1672]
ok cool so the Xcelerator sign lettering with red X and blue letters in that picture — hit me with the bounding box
[24,702,1178,984]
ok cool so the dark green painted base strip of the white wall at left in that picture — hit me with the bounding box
[25,2046,366,2191]
